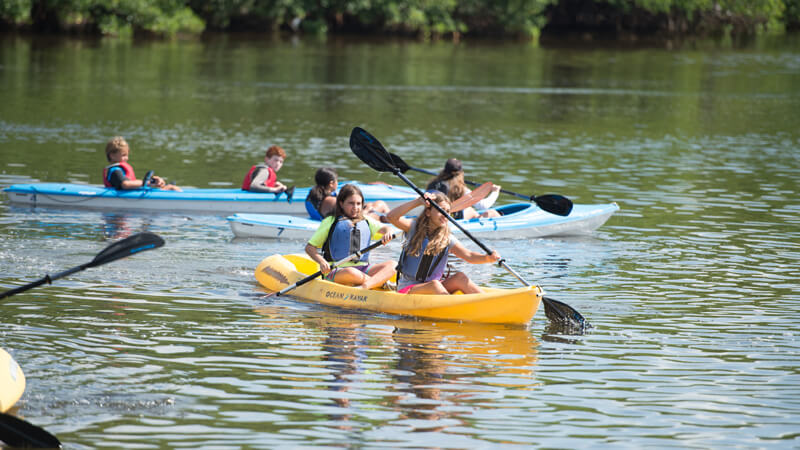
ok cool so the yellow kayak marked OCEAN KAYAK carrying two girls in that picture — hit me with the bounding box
[255,255,542,325]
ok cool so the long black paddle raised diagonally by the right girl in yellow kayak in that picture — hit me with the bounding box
[350,127,590,329]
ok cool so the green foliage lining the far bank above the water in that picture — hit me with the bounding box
[0,0,800,37]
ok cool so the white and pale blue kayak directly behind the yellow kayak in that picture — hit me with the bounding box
[227,203,619,239]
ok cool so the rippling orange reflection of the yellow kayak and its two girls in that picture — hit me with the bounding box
[255,305,539,432]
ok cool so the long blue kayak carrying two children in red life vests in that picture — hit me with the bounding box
[4,183,417,216]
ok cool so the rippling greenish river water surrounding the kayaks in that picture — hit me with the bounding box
[0,36,800,448]
